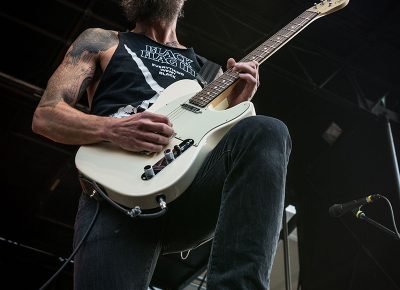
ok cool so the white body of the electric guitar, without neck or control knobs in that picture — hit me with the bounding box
[75,80,255,209]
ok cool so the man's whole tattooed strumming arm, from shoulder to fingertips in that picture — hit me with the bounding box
[32,29,173,152]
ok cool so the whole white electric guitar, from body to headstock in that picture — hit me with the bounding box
[75,0,349,209]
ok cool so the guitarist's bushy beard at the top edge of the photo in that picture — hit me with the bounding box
[121,0,186,23]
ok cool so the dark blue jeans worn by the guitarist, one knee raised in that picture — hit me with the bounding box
[74,116,291,290]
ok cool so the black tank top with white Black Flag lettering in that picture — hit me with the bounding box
[91,32,207,118]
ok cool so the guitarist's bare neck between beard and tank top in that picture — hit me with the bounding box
[133,19,184,48]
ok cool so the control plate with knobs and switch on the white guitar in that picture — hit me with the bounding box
[141,139,194,180]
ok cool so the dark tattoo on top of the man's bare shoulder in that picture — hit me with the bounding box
[67,28,118,60]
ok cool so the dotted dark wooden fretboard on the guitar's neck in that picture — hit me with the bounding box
[189,9,318,108]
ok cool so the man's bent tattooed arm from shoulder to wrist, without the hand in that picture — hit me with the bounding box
[32,29,118,144]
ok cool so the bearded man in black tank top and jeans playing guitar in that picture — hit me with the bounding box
[32,0,291,290]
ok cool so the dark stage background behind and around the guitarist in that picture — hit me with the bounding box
[0,0,400,290]
